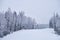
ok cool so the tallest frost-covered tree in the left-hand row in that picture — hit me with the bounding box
[5,8,13,33]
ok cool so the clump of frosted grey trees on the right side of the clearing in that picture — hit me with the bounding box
[49,13,60,35]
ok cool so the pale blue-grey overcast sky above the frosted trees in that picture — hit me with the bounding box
[0,0,60,24]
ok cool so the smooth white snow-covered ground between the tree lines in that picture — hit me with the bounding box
[1,28,60,40]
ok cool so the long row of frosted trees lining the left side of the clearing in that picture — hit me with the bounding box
[0,8,36,37]
